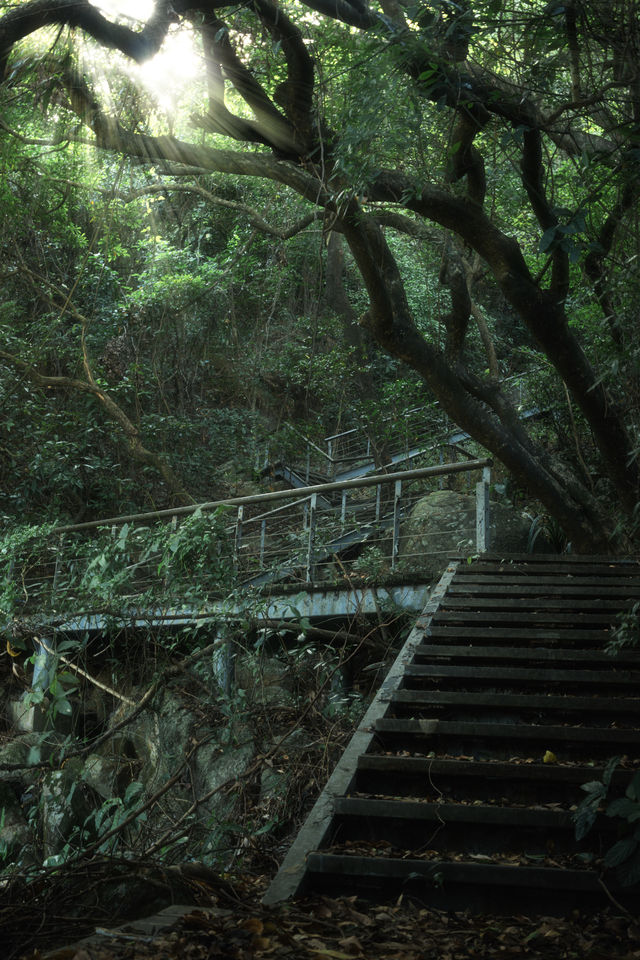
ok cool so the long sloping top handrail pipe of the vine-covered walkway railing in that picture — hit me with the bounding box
[50,459,493,536]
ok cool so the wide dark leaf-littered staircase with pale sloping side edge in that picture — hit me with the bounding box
[265,556,640,914]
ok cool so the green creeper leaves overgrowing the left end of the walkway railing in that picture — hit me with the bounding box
[0,508,234,623]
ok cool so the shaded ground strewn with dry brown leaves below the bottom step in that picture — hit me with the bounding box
[12,879,640,960]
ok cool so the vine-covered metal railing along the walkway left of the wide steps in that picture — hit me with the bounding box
[5,459,491,610]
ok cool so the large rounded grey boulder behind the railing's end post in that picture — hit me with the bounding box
[400,490,549,579]
